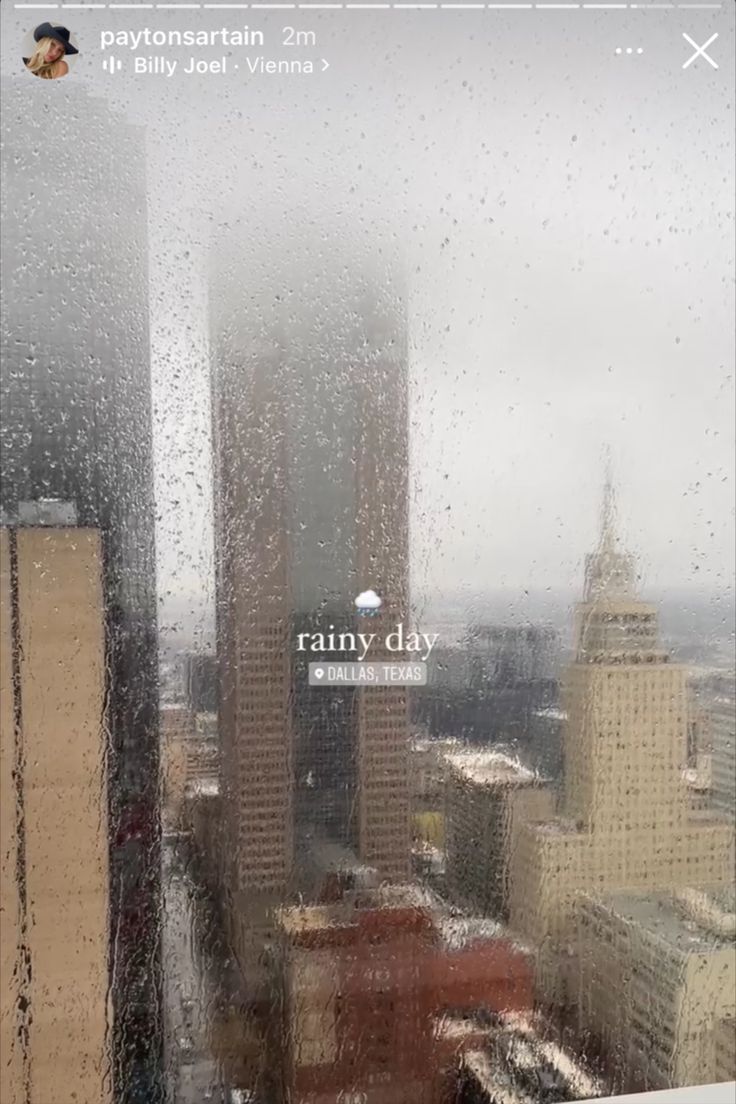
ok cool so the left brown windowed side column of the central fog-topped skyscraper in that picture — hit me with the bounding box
[213,342,294,975]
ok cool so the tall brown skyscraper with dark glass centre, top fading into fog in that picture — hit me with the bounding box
[212,221,410,975]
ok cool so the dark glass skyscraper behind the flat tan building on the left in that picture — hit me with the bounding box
[0,79,161,1104]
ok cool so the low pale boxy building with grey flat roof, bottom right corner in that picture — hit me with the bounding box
[577,887,736,1091]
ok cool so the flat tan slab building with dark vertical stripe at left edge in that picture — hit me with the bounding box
[0,527,111,1104]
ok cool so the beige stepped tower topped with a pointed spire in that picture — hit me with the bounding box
[510,486,734,1000]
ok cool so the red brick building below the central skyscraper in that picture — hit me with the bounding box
[279,885,532,1104]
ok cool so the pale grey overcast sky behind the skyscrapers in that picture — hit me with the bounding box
[3,3,734,631]
